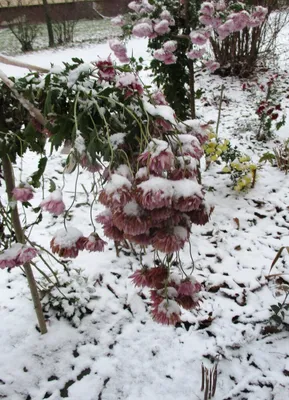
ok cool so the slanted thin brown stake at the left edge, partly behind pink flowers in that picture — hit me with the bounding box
[2,155,47,334]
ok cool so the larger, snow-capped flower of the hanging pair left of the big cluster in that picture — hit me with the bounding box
[50,228,86,258]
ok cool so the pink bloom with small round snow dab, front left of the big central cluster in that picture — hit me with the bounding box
[112,200,149,236]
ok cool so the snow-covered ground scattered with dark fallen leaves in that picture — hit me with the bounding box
[0,23,289,400]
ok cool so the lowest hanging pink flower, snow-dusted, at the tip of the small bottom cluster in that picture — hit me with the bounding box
[152,299,181,325]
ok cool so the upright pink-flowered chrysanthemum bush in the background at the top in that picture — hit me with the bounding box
[112,0,267,118]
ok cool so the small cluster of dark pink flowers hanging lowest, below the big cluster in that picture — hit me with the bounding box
[130,266,201,325]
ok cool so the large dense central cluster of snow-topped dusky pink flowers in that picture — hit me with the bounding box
[97,121,210,254]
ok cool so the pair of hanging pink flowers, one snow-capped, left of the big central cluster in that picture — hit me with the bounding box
[50,227,107,258]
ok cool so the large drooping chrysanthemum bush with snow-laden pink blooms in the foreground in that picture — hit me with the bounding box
[0,55,211,324]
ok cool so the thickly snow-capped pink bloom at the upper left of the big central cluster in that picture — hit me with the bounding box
[99,174,132,208]
